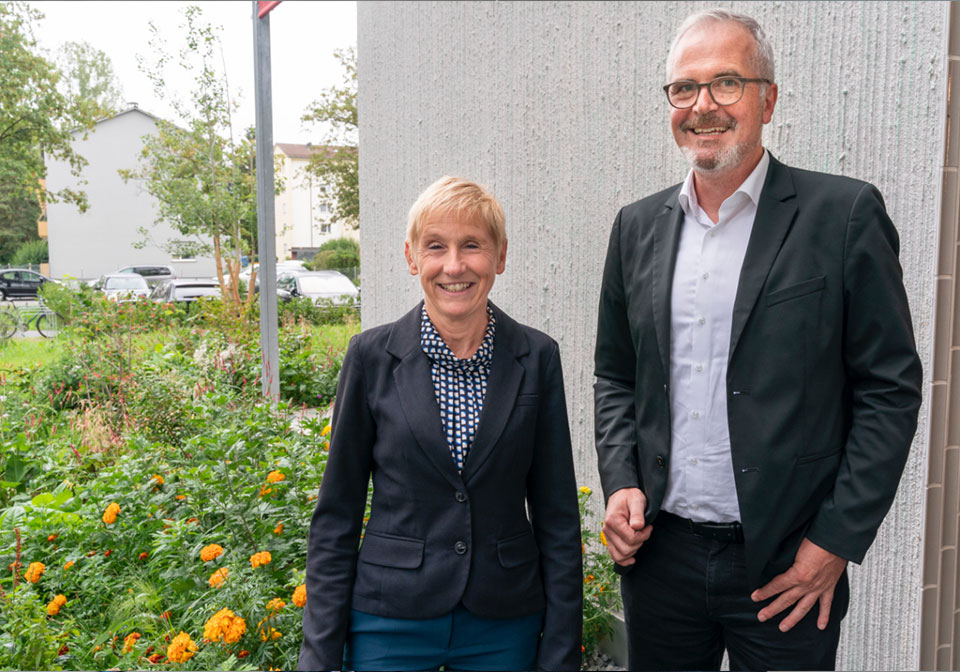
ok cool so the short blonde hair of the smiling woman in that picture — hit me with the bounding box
[407,175,507,251]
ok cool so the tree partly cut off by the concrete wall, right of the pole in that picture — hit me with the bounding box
[301,47,360,227]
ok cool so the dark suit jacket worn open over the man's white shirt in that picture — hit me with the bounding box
[595,157,921,587]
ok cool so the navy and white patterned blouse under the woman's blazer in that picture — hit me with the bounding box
[420,306,497,472]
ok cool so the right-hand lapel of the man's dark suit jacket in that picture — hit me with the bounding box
[729,154,797,359]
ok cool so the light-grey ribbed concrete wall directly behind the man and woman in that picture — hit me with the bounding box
[358,2,948,669]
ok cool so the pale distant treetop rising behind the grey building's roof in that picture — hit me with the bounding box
[56,42,123,119]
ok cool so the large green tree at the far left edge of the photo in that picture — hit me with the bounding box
[0,2,95,223]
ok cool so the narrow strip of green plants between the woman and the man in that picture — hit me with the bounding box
[577,487,621,656]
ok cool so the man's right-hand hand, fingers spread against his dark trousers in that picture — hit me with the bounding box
[752,540,847,632]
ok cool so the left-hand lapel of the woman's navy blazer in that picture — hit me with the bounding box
[387,302,463,488]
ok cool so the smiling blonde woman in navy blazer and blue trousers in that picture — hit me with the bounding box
[299,177,582,670]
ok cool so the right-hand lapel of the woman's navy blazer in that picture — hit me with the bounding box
[463,303,530,481]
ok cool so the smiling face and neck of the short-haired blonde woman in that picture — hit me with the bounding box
[404,214,507,324]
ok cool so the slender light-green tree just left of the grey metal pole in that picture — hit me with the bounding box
[121,6,282,307]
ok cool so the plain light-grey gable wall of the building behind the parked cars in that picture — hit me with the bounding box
[47,110,216,279]
